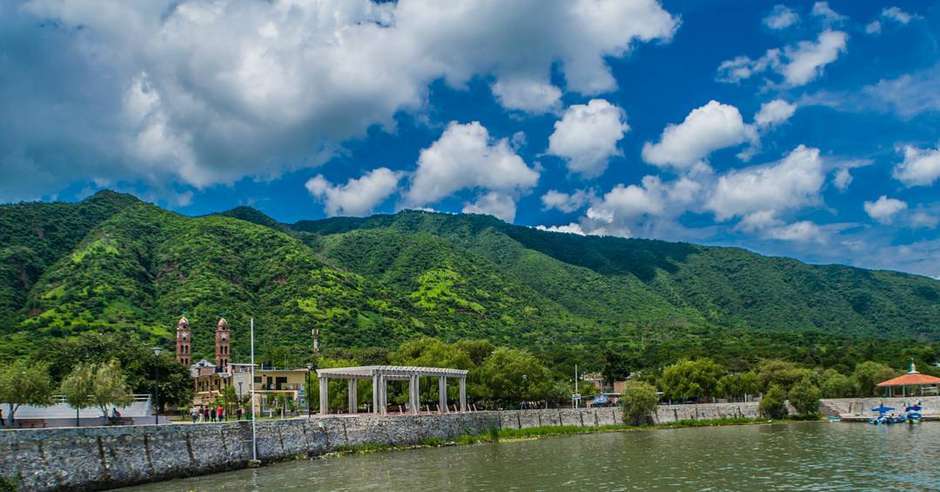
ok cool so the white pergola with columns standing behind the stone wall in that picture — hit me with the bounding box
[317,366,467,415]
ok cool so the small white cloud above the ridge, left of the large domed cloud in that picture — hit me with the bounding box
[305,167,401,217]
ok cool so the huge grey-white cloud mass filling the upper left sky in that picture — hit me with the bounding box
[0,0,679,199]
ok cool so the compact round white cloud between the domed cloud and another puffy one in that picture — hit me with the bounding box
[548,99,630,178]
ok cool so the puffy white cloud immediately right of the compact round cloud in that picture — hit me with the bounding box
[642,101,755,170]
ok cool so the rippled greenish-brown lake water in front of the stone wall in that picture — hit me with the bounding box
[129,423,940,491]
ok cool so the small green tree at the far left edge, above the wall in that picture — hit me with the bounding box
[0,359,53,426]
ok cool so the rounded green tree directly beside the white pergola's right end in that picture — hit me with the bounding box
[478,347,559,403]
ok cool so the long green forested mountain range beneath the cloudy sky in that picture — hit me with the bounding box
[0,192,940,368]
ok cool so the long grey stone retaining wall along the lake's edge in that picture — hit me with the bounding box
[0,403,757,490]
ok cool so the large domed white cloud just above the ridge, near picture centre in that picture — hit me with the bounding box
[405,121,539,207]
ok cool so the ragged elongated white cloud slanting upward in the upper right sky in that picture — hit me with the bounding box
[716,29,848,87]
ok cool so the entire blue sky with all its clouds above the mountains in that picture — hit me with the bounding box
[0,0,940,277]
